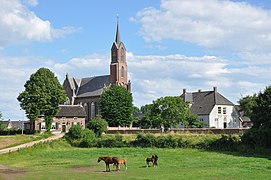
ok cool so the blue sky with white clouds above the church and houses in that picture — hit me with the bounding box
[0,0,271,120]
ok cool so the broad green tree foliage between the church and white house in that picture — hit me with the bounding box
[140,96,204,128]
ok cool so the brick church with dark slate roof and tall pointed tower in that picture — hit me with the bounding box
[63,22,131,123]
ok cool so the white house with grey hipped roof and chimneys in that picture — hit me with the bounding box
[181,87,242,128]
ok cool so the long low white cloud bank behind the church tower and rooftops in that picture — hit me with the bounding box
[0,52,271,119]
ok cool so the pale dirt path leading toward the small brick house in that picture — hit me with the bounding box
[0,133,64,154]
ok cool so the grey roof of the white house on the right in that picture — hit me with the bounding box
[181,88,234,115]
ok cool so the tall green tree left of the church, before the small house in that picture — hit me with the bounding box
[17,68,66,132]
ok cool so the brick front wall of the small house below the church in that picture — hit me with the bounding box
[35,117,85,134]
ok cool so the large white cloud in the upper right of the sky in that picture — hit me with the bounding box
[131,0,271,55]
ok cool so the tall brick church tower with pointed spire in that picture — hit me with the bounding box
[110,22,131,92]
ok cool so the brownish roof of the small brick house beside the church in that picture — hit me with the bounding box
[55,105,86,117]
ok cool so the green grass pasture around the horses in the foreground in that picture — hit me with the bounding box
[0,140,271,180]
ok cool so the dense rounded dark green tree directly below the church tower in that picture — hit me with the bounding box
[100,86,133,126]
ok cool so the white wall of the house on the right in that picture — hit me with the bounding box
[209,105,241,128]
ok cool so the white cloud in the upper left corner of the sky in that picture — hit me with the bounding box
[0,0,75,48]
